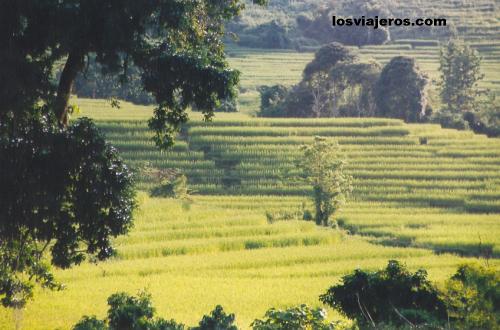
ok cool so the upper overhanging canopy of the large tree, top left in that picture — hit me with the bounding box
[0,0,265,147]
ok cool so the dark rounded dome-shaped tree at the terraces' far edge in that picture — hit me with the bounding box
[375,56,428,122]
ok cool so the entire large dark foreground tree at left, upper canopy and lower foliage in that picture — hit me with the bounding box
[0,0,264,308]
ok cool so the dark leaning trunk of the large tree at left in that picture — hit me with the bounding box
[54,51,85,126]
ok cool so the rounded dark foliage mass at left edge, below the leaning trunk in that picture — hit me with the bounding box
[0,119,135,308]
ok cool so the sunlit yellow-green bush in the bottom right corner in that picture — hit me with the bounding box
[442,265,500,329]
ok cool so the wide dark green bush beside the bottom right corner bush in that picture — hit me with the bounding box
[320,260,447,327]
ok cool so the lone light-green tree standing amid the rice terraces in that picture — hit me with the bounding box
[299,136,352,226]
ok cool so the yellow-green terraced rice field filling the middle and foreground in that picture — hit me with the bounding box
[0,100,500,329]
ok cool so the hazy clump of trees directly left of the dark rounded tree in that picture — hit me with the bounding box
[260,43,380,118]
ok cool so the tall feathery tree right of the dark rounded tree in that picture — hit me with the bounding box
[439,40,484,113]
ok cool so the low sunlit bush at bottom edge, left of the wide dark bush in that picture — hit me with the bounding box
[252,305,335,330]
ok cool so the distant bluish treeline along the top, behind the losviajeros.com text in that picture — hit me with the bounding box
[227,0,457,51]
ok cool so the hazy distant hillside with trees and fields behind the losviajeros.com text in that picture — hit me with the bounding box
[228,0,500,49]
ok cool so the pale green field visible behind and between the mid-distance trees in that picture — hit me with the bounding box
[227,41,500,114]
